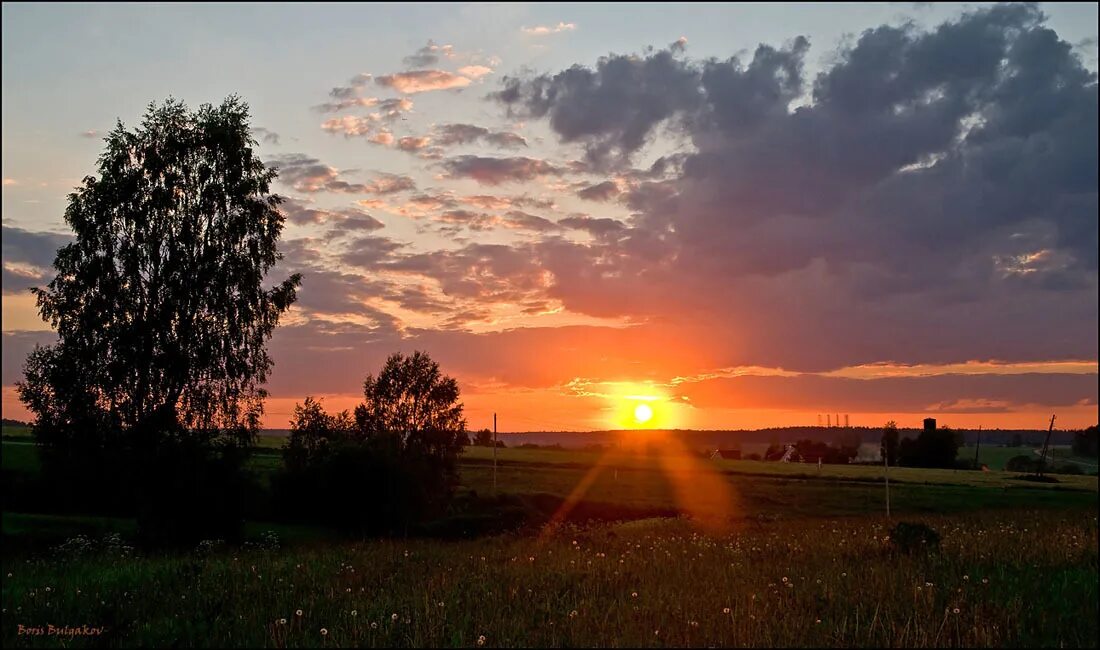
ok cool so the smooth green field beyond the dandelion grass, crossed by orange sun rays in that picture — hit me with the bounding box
[3,441,1098,525]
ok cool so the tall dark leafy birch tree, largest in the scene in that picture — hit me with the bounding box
[18,97,300,538]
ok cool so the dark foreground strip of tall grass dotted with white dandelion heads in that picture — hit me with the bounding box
[2,509,1100,647]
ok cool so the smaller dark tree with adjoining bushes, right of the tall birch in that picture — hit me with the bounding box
[275,352,469,533]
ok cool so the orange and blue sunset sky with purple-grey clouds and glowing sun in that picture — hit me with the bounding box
[2,3,1098,431]
